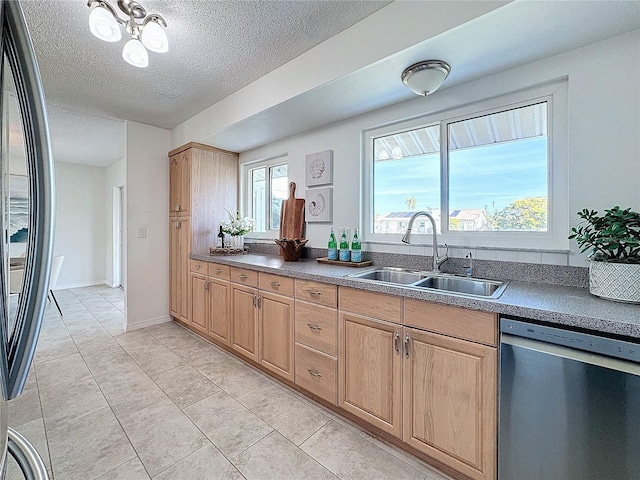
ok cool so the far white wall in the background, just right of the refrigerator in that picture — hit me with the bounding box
[54,162,107,289]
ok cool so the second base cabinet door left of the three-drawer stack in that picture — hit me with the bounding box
[231,283,258,362]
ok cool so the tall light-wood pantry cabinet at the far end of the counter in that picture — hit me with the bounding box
[169,142,238,324]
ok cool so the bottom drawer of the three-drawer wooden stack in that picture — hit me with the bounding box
[295,343,338,405]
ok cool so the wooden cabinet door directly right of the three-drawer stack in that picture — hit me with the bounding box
[338,312,402,438]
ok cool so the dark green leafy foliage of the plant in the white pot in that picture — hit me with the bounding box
[569,206,640,264]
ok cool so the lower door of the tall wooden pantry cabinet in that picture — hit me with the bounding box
[169,218,191,322]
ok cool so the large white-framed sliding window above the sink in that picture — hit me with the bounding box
[364,83,568,250]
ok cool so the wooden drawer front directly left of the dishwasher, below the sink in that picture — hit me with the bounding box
[404,298,498,347]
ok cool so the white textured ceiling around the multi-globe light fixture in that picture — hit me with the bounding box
[21,0,389,165]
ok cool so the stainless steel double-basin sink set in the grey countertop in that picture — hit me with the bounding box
[346,267,508,299]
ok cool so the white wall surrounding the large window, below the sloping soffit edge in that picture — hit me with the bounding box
[240,31,640,266]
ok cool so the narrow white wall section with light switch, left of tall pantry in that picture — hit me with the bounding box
[124,121,171,330]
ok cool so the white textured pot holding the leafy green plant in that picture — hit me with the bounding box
[589,260,640,303]
